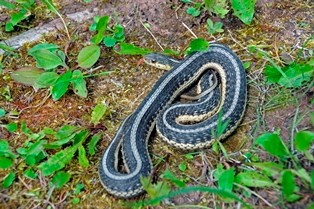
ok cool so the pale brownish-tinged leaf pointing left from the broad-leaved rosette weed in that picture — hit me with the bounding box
[11,67,44,86]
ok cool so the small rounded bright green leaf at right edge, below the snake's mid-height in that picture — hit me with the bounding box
[294,131,314,152]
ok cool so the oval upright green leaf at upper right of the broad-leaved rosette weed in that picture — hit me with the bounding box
[77,45,100,68]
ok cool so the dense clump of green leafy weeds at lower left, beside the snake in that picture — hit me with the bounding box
[0,122,102,190]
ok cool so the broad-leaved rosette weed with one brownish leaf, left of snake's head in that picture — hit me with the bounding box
[11,43,109,100]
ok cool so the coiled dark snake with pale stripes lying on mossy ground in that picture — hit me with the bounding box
[98,43,247,198]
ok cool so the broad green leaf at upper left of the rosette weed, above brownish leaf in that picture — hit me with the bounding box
[30,49,64,70]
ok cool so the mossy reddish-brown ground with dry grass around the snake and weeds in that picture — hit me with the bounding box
[0,0,314,208]
